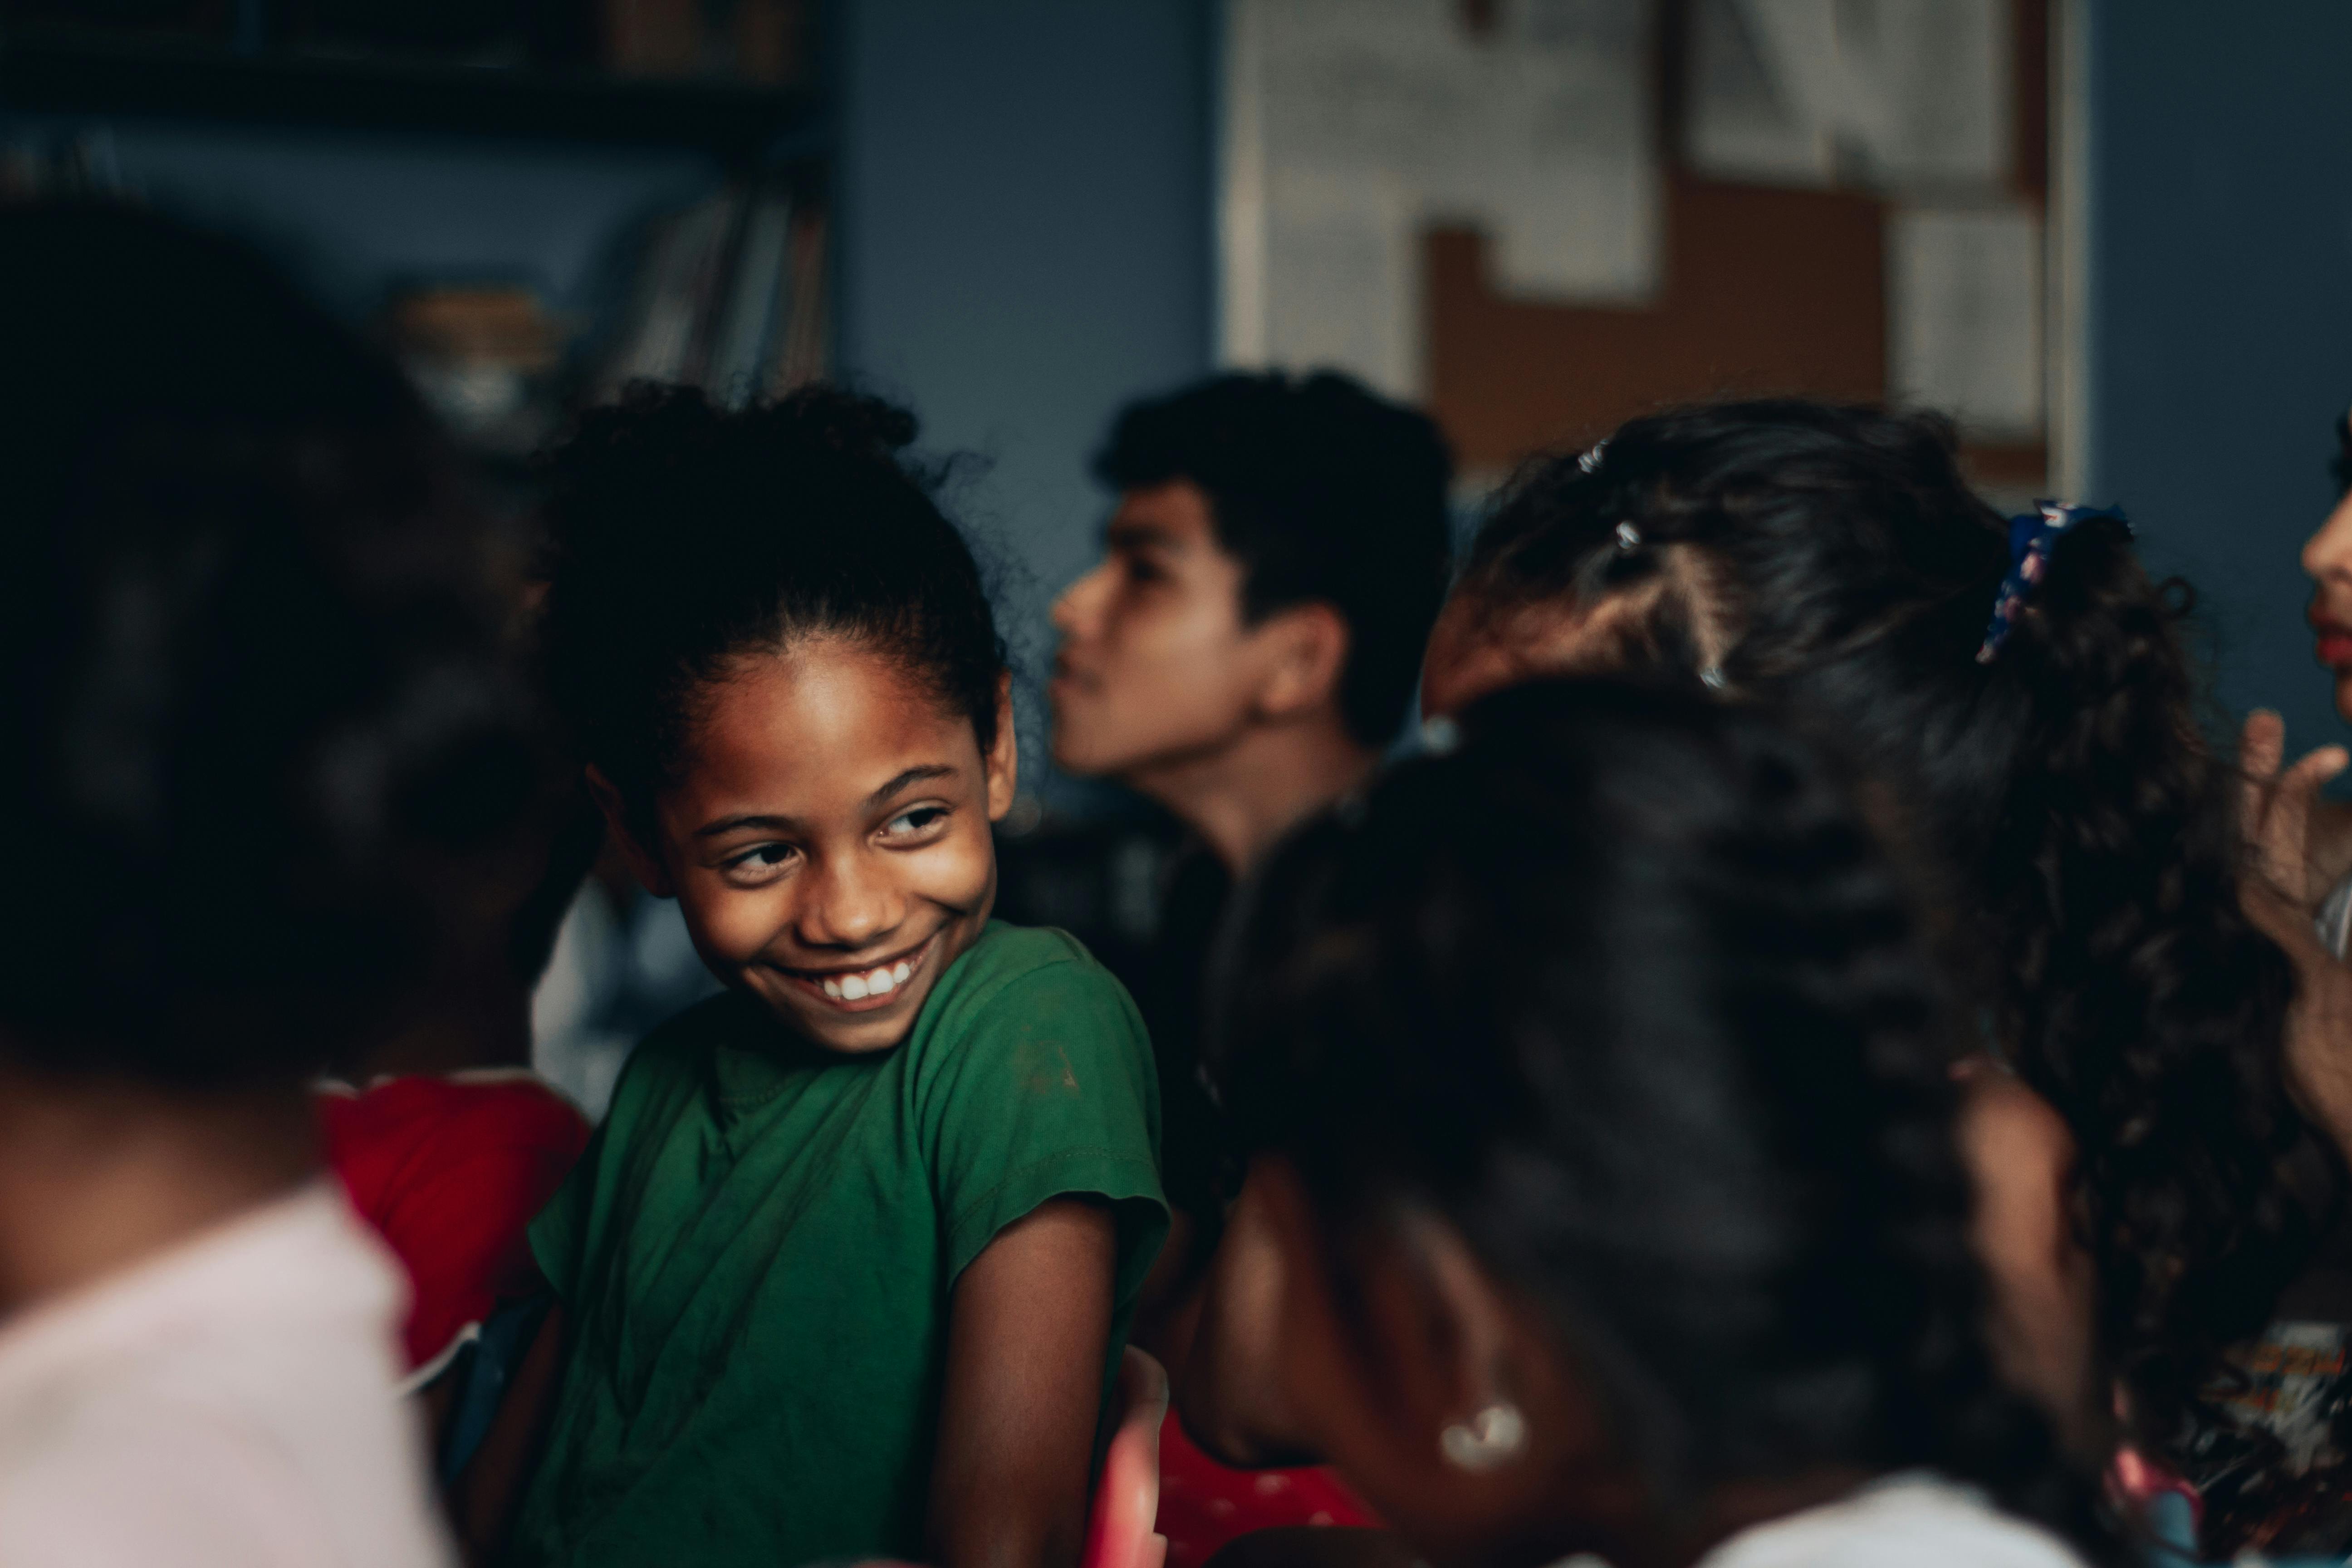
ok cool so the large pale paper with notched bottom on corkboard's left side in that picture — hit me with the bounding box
[1220,0,1661,397]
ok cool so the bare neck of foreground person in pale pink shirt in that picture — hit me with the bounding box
[0,1067,318,1321]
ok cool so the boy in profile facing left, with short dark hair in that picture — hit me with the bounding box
[1047,376,1451,1375]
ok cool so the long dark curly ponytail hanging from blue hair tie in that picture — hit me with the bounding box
[1980,522,2317,1439]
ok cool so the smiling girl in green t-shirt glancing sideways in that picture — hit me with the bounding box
[470,390,1166,1568]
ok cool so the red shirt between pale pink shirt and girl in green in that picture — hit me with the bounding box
[318,1067,588,1371]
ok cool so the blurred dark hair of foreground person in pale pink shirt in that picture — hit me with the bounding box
[0,205,546,1088]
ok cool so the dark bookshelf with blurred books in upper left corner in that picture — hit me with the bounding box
[0,0,833,461]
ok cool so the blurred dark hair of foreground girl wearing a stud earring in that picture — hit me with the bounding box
[1223,682,2102,1552]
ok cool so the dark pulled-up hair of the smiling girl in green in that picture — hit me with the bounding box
[546,383,1007,832]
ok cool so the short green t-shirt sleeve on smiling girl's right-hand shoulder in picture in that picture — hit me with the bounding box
[917,931,1166,1300]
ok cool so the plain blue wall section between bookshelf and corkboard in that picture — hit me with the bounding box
[835,0,1216,778]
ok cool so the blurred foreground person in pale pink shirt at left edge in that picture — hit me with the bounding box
[0,205,544,1568]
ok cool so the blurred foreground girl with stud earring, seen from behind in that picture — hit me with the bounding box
[1220,682,2124,1568]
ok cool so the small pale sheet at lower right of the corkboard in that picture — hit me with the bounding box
[1886,207,2042,440]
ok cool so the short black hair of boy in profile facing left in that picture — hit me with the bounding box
[1094,374,1454,745]
